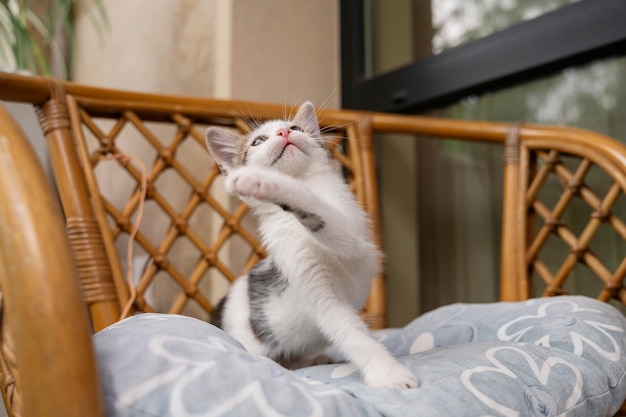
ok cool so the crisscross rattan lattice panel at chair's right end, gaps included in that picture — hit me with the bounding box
[526,150,626,303]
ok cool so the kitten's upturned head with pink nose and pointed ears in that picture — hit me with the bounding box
[206,103,330,177]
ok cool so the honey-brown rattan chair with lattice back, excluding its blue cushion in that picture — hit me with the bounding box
[0,73,626,417]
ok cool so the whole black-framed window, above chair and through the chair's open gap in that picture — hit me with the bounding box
[341,0,626,318]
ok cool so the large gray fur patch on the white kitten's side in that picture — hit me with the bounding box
[248,258,287,346]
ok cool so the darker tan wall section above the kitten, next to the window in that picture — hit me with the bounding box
[231,0,339,108]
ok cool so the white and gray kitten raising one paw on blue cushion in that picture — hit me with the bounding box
[206,102,417,388]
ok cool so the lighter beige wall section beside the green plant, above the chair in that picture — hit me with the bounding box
[74,0,217,96]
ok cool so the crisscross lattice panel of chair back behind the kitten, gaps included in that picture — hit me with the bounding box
[65,99,363,319]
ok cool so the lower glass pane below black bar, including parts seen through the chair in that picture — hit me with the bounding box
[417,57,626,310]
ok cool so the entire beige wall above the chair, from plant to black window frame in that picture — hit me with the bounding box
[74,0,340,108]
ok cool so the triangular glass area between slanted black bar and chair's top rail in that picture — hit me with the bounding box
[435,57,626,136]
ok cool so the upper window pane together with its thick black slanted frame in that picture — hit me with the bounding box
[341,0,626,112]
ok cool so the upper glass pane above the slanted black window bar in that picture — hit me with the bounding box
[364,0,580,78]
